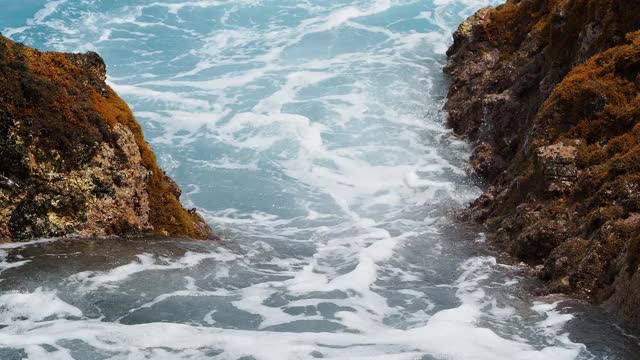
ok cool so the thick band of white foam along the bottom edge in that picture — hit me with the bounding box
[0,308,580,360]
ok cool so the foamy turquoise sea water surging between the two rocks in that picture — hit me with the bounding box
[0,0,640,360]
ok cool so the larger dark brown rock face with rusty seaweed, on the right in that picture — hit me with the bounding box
[445,0,640,323]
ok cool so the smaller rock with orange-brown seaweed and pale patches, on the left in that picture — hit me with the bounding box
[0,35,214,241]
